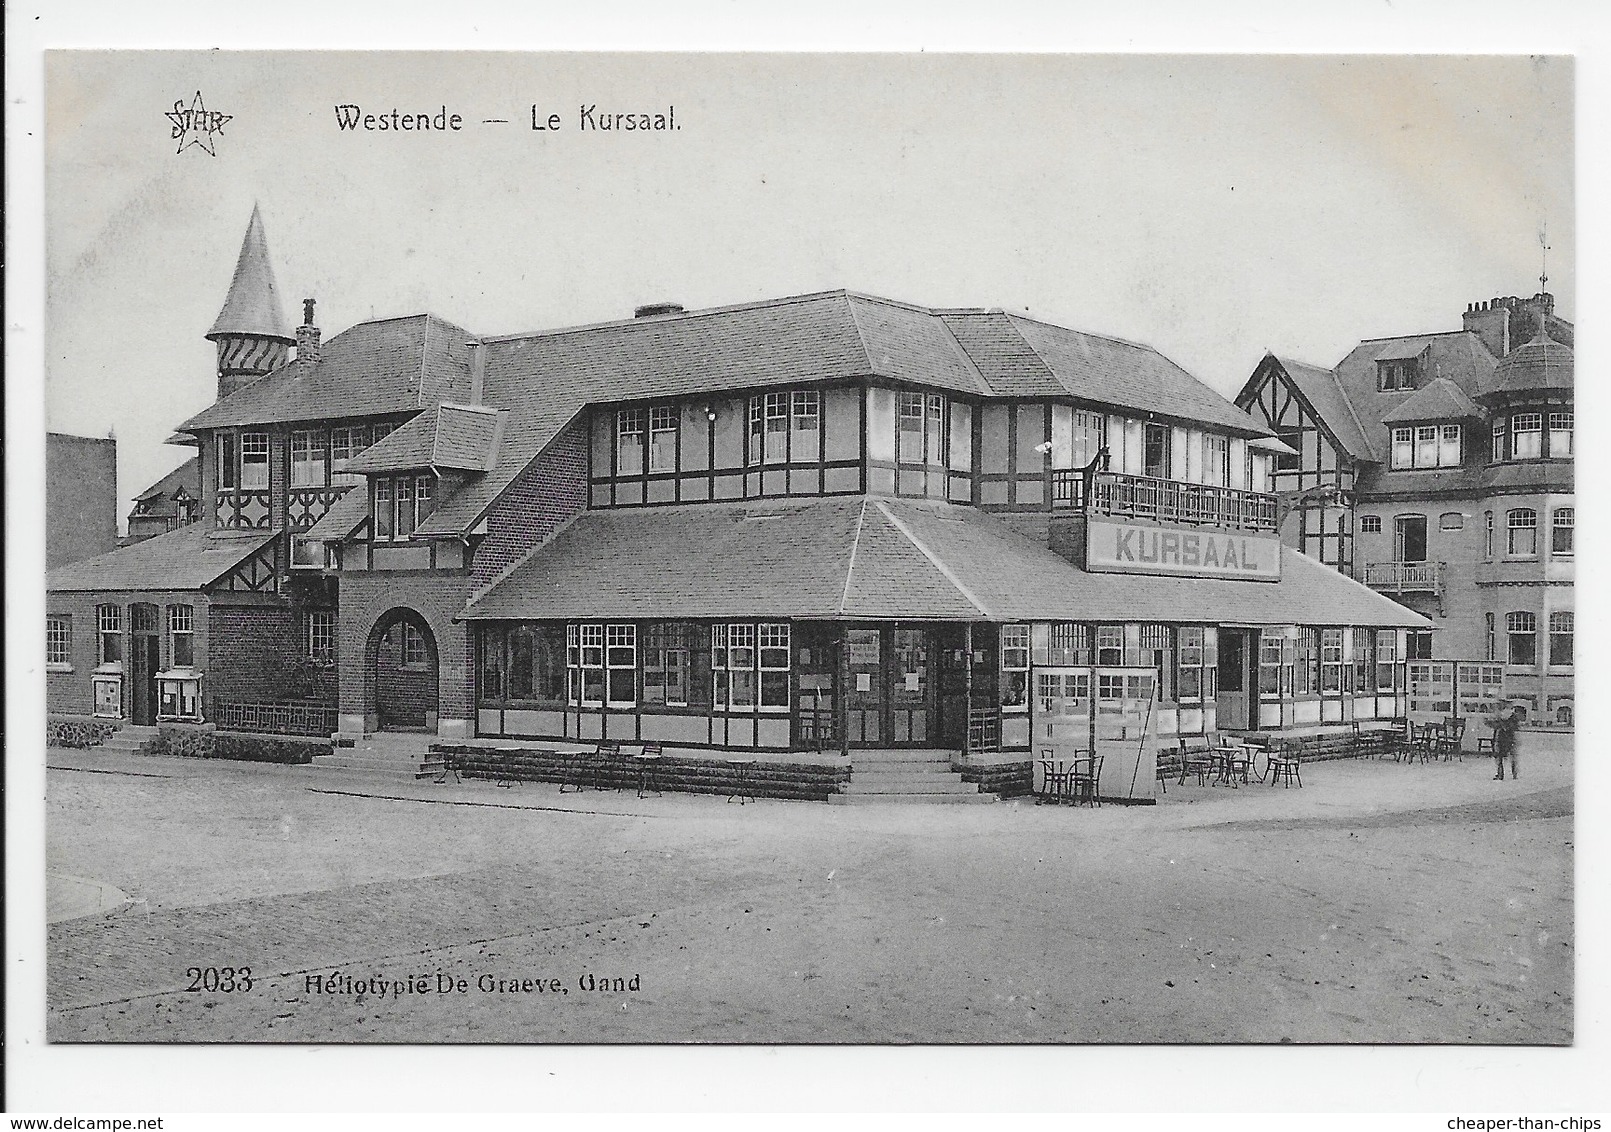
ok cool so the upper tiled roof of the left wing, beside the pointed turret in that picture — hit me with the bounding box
[179,314,470,432]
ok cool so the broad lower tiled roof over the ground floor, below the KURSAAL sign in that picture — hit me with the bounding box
[464,496,1426,625]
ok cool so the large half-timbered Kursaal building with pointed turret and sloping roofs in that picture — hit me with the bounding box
[48,213,1432,797]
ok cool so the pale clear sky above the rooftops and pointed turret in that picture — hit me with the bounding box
[45,52,1576,528]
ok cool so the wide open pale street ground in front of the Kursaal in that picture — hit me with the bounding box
[48,752,1574,1043]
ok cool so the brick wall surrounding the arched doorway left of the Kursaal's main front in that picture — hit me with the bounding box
[337,572,472,729]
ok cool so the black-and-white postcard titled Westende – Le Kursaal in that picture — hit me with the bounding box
[12,26,1577,1114]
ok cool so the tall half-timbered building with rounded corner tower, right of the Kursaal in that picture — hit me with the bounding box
[1237,291,1576,726]
